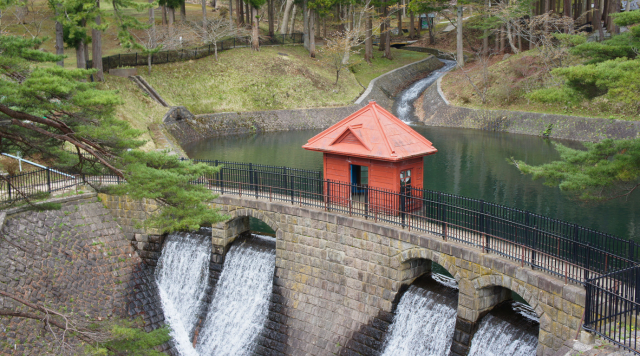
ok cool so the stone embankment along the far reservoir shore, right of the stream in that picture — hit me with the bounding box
[414,77,640,141]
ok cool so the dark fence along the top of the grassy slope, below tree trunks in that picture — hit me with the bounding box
[87,33,303,72]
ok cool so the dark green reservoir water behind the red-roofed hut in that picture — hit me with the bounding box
[184,126,640,241]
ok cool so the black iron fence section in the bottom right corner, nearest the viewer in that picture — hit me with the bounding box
[584,266,640,355]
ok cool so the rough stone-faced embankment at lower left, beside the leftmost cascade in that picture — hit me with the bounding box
[0,194,169,355]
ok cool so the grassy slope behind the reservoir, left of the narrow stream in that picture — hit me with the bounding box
[142,46,426,114]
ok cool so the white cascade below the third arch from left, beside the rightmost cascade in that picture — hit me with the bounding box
[382,286,457,356]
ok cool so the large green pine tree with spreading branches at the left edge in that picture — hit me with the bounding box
[0,36,228,232]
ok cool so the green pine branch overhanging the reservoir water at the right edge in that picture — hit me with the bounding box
[512,139,640,201]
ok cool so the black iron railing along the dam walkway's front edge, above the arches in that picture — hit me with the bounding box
[0,160,640,283]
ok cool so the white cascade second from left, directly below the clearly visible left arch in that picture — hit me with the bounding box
[196,243,276,356]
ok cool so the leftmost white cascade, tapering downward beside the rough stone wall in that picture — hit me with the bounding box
[156,233,211,356]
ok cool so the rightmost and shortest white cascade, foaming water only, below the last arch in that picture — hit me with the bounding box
[469,314,538,356]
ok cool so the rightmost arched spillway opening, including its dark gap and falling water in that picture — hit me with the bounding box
[469,289,540,356]
